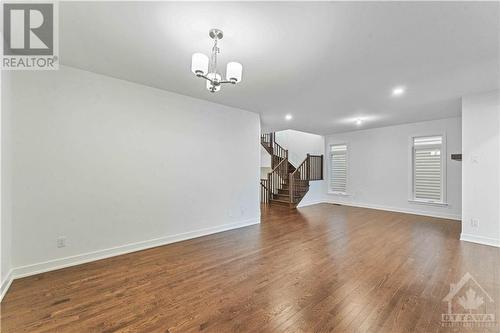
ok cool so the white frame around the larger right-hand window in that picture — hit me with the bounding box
[408,133,448,206]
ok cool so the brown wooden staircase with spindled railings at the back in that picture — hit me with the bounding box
[260,133,323,208]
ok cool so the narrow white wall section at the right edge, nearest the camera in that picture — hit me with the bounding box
[461,91,500,246]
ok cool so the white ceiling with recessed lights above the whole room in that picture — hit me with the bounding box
[59,2,500,134]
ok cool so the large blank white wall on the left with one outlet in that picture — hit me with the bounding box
[3,67,260,276]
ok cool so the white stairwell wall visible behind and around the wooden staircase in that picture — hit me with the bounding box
[276,130,325,207]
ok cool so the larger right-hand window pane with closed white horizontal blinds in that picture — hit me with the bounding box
[413,136,445,203]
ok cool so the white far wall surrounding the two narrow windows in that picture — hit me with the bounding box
[326,118,461,219]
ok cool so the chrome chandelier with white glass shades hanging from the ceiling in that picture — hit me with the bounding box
[191,29,243,93]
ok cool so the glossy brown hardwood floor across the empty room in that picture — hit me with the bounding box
[0,204,500,333]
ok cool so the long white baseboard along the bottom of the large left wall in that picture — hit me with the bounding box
[2,217,260,296]
